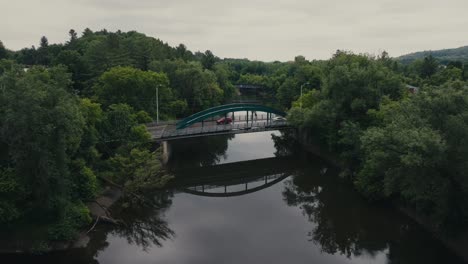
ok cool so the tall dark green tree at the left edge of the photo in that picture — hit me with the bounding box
[0,67,84,221]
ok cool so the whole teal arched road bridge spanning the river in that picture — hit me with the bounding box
[147,103,290,141]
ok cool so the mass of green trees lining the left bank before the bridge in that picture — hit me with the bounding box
[0,60,171,241]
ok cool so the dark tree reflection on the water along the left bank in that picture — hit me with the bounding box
[0,191,175,264]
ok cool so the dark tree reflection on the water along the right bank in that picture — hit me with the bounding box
[282,162,460,263]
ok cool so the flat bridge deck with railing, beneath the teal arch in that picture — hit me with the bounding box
[147,120,291,141]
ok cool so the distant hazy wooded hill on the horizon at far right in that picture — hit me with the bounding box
[397,46,468,63]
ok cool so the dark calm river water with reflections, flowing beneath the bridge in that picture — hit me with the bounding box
[0,132,462,264]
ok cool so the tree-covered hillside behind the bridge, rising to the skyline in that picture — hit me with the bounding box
[0,29,330,113]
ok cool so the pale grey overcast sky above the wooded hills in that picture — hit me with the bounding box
[0,0,468,61]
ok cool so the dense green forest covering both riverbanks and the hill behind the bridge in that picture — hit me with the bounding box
[0,29,468,245]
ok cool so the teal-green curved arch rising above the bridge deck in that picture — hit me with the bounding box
[176,104,286,129]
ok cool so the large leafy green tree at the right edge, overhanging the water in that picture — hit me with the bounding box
[356,83,468,228]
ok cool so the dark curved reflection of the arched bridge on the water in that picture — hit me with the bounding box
[168,157,298,197]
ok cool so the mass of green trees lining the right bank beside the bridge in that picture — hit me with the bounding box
[289,52,468,231]
